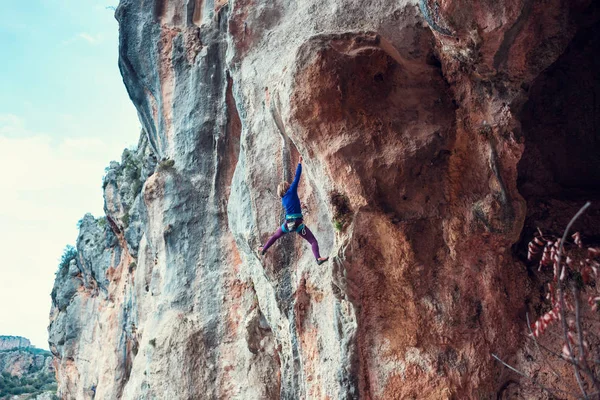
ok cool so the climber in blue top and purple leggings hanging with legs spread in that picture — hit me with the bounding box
[258,156,329,265]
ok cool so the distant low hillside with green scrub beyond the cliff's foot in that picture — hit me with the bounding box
[0,336,58,400]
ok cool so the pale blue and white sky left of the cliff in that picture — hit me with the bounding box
[0,0,141,349]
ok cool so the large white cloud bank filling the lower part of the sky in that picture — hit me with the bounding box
[0,114,119,347]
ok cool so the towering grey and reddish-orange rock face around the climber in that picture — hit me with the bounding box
[49,0,600,399]
